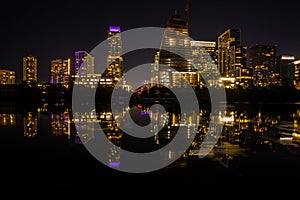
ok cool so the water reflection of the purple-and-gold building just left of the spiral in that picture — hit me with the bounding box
[50,111,71,139]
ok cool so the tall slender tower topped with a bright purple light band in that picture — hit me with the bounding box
[102,26,124,85]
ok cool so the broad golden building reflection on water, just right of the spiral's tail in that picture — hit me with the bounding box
[213,108,280,167]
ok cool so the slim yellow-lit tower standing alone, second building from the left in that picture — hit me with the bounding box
[23,56,37,84]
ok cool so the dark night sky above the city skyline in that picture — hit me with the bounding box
[0,0,300,82]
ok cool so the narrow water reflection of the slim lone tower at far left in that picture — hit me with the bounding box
[23,112,37,138]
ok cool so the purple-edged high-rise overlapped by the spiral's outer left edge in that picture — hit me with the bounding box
[75,51,95,75]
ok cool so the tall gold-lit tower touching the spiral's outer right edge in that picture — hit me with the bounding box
[218,29,247,77]
